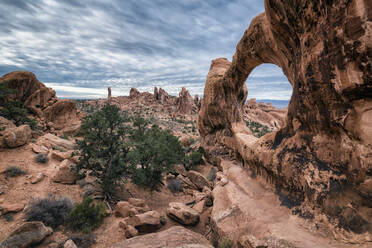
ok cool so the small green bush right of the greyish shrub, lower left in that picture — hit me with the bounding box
[67,197,106,233]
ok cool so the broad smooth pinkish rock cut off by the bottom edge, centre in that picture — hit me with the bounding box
[111,226,213,248]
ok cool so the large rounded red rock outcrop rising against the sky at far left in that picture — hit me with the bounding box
[0,71,80,134]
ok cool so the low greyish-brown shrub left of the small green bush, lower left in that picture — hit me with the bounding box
[26,195,73,228]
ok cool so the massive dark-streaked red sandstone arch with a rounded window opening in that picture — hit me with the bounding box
[198,0,372,240]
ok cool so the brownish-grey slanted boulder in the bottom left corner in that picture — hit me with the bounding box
[0,221,53,248]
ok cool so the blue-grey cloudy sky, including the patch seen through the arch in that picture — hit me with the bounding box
[0,0,291,99]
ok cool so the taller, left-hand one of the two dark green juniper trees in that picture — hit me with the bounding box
[75,104,129,197]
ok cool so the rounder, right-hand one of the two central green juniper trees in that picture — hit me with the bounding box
[128,117,184,190]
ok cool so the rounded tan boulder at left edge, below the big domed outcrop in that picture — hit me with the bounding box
[3,125,31,148]
